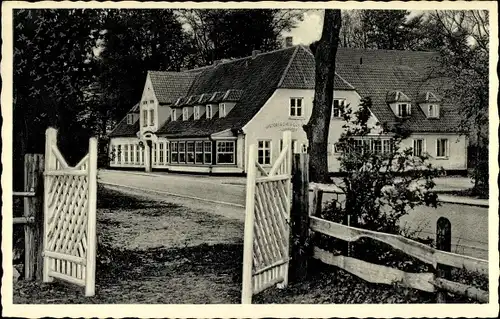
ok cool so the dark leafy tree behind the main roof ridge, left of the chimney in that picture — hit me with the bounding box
[178,9,303,65]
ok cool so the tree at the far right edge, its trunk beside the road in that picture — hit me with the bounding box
[422,10,489,196]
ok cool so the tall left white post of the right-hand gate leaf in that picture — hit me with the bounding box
[241,144,257,304]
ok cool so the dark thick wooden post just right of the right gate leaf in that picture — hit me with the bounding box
[290,153,310,282]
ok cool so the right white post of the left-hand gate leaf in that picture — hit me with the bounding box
[85,138,97,297]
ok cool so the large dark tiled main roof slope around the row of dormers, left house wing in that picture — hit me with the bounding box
[158,47,303,136]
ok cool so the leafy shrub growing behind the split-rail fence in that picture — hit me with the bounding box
[326,98,440,234]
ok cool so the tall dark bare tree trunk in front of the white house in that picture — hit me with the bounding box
[304,9,341,182]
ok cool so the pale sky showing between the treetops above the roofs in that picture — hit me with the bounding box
[283,10,423,45]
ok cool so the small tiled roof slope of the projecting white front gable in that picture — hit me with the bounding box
[148,71,198,104]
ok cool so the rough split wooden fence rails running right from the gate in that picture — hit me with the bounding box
[309,183,489,303]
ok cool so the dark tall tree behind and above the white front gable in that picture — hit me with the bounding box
[94,9,191,133]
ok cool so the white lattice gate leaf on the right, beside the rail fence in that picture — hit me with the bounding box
[241,131,292,304]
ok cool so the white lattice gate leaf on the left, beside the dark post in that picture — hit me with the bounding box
[43,128,97,296]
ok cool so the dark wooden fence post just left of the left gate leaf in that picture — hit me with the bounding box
[24,154,44,280]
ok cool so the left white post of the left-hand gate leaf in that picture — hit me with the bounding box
[42,127,57,282]
